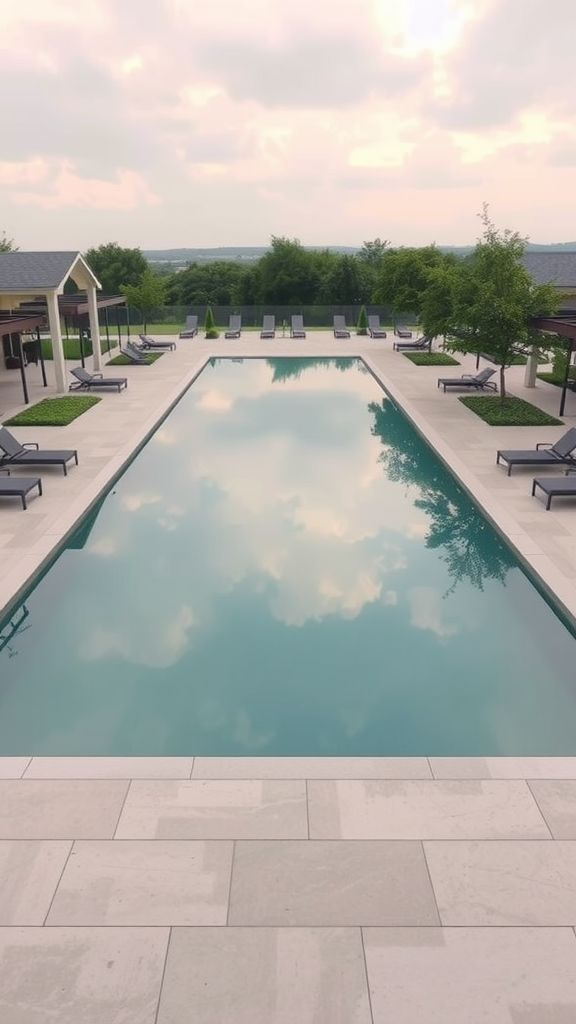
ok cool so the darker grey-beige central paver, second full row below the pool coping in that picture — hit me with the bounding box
[229,842,439,928]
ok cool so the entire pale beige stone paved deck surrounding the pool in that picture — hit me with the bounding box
[0,333,576,1024]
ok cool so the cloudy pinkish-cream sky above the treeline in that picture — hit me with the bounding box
[0,0,576,250]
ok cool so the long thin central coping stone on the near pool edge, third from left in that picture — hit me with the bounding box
[192,757,431,778]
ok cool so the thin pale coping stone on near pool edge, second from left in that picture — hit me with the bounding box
[24,757,194,779]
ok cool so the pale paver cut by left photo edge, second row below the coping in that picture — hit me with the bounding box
[0,840,72,929]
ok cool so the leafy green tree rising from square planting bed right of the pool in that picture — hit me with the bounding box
[434,204,558,402]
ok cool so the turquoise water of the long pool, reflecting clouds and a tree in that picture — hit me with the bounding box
[0,359,576,755]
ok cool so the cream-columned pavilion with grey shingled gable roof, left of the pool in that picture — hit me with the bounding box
[0,252,101,394]
